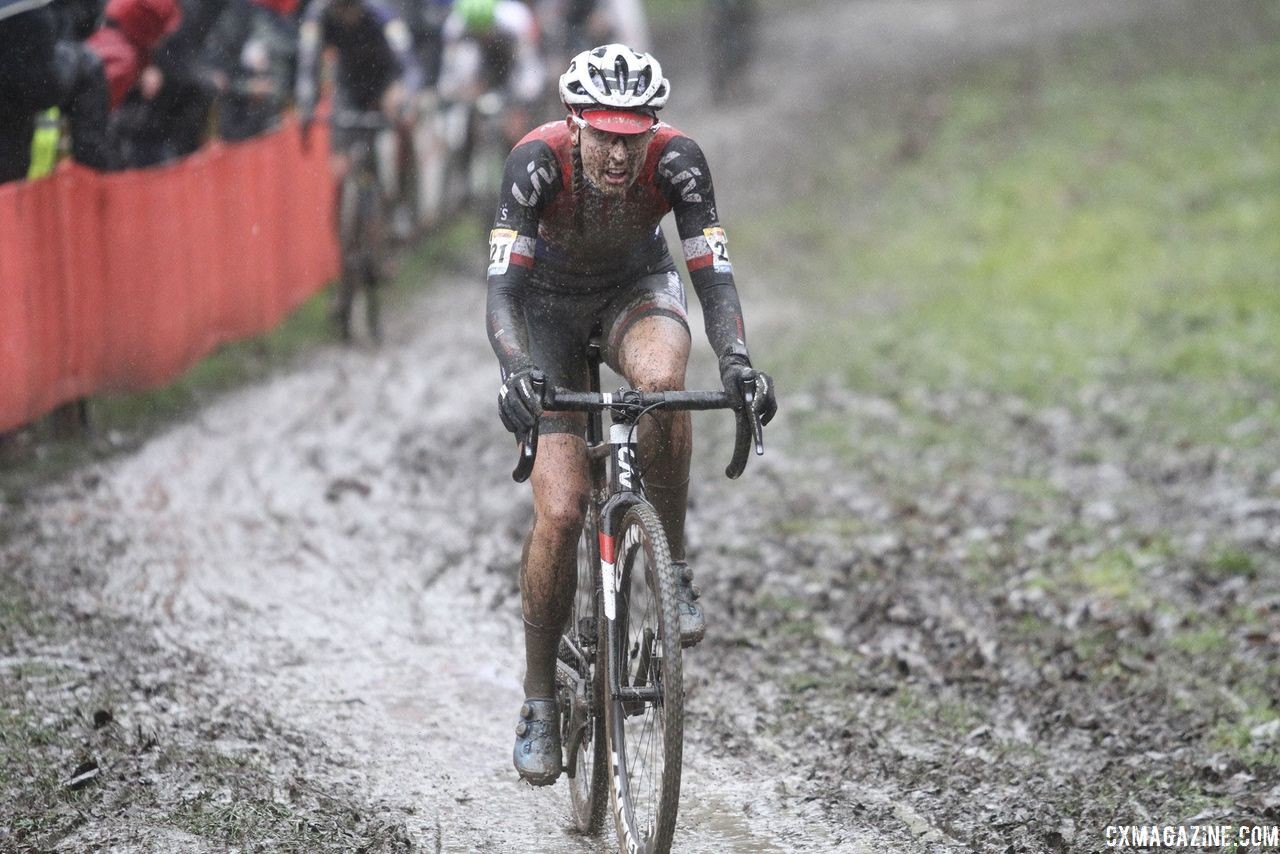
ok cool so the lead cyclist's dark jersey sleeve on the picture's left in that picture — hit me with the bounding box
[486,140,562,374]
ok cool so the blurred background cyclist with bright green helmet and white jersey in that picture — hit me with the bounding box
[440,0,547,145]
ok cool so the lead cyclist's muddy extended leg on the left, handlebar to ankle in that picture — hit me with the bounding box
[520,433,588,697]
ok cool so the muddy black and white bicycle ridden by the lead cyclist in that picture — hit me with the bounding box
[512,342,764,854]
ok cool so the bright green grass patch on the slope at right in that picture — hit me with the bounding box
[762,25,1280,439]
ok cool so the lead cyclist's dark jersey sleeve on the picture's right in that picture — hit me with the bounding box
[654,136,746,357]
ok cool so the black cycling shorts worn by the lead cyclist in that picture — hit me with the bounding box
[524,268,689,435]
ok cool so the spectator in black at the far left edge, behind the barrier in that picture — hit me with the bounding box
[0,0,60,183]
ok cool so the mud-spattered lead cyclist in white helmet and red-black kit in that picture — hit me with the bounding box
[488,45,777,785]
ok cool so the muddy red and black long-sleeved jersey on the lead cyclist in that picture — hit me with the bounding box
[489,122,745,371]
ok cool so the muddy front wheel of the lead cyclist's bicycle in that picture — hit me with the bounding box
[604,504,685,854]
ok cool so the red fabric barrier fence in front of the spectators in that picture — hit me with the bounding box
[0,119,339,431]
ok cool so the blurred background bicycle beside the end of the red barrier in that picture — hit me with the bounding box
[330,110,392,341]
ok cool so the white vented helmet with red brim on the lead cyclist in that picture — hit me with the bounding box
[559,45,671,133]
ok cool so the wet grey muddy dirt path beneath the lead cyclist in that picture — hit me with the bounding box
[2,0,1208,851]
